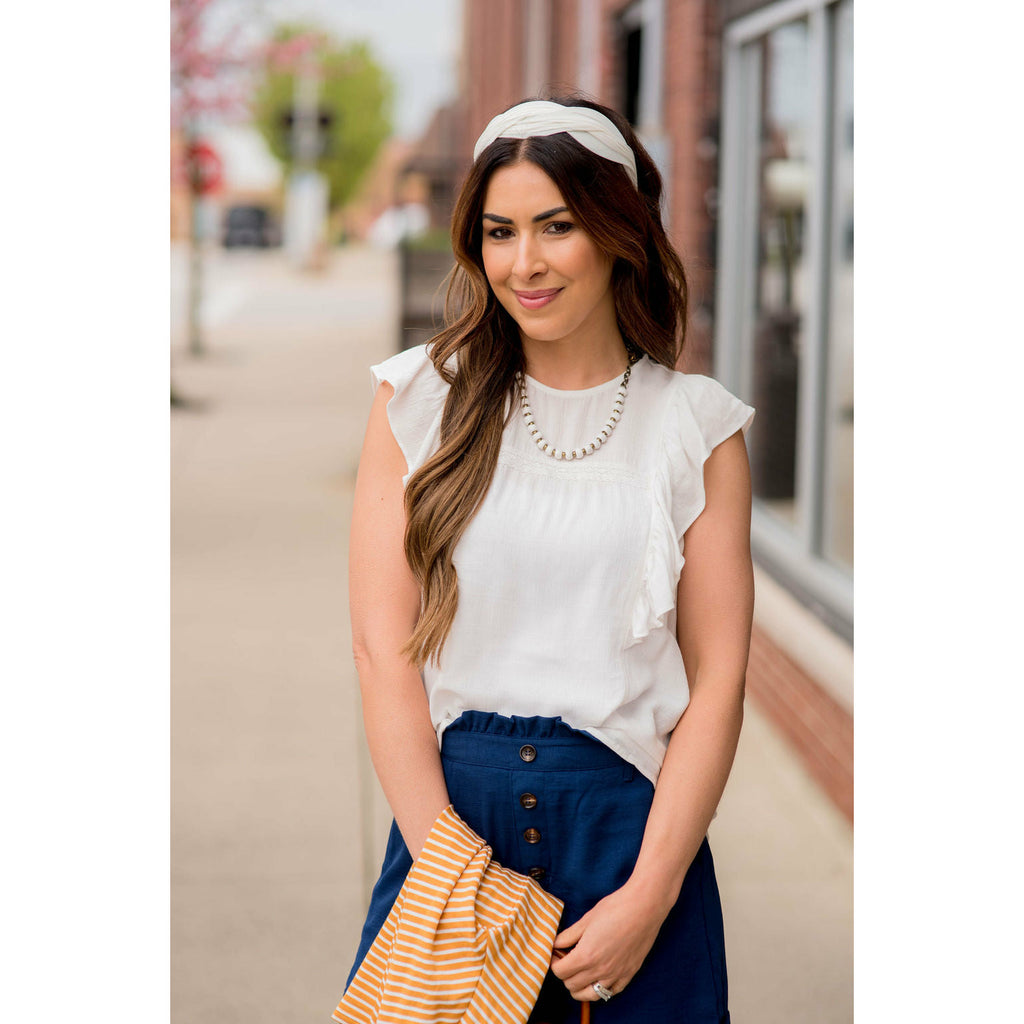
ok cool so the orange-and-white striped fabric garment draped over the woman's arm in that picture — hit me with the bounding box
[332,807,562,1024]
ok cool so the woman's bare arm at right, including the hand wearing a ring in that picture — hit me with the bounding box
[552,431,754,999]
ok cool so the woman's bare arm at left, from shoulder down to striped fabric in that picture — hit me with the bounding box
[348,382,449,858]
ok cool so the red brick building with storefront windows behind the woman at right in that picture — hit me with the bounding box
[452,0,853,820]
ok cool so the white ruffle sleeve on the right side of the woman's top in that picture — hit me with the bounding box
[626,374,754,647]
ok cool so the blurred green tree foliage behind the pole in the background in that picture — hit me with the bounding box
[253,25,394,209]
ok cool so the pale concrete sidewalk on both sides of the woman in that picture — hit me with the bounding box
[171,243,853,1024]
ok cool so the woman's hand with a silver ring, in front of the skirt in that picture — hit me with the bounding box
[551,883,667,1001]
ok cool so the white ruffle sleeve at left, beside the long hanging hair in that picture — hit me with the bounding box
[370,345,449,486]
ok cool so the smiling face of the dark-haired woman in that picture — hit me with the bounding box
[481,161,617,352]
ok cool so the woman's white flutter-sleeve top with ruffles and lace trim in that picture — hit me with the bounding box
[371,345,754,782]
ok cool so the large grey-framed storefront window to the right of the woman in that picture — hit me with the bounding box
[715,0,853,635]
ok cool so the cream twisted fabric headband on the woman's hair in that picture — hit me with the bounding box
[473,99,639,187]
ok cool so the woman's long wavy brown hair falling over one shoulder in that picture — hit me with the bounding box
[402,96,687,669]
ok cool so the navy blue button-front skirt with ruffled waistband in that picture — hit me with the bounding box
[346,711,729,1024]
